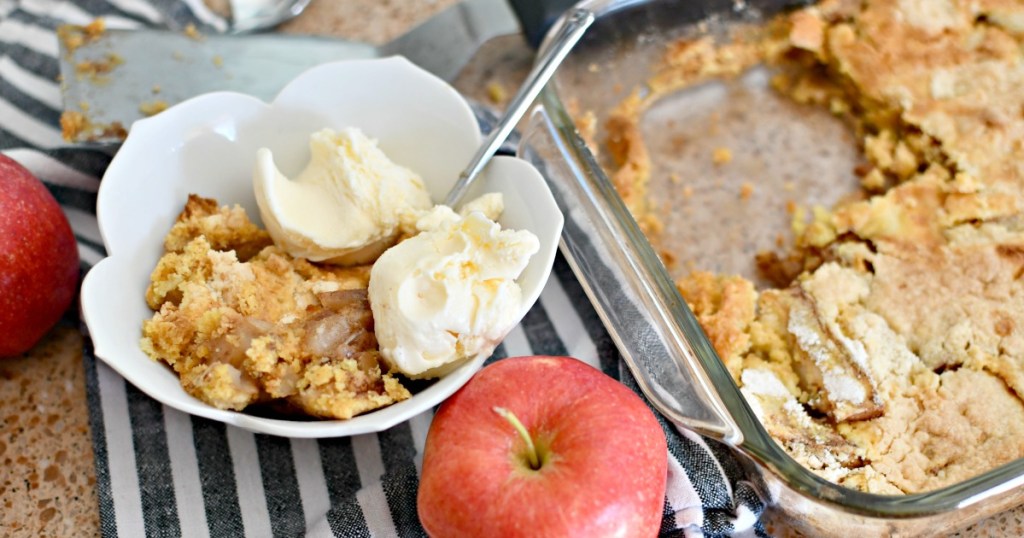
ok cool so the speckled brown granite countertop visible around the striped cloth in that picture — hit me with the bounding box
[6,0,1024,537]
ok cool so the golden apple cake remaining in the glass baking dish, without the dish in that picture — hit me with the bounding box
[594,0,1024,494]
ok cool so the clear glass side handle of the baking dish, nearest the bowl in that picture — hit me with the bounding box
[519,98,742,445]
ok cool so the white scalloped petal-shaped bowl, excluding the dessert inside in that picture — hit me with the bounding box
[81,57,562,438]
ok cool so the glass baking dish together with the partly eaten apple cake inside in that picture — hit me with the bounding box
[527,0,1024,534]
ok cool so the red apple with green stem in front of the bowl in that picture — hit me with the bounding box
[418,357,668,537]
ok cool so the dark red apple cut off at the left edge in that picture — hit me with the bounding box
[0,155,78,357]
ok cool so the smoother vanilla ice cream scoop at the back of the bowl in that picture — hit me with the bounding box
[253,128,431,265]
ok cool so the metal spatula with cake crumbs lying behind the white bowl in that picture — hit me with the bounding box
[60,0,568,143]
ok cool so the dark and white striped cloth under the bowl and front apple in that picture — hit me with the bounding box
[0,0,764,537]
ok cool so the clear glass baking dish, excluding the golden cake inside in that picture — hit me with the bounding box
[521,0,1024,536]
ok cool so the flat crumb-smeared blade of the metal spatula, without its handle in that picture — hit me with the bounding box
[60,30,379,143]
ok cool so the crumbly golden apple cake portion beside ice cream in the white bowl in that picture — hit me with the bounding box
[141,196,411,419]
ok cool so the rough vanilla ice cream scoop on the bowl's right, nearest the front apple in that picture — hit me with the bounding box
[370,205,540,377]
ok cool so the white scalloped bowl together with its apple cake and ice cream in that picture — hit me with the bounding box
[82,57,562,437]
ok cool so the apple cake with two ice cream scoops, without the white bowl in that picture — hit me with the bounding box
[141,127,540,419]
